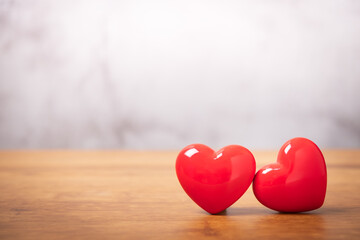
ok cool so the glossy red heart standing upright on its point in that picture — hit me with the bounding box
[176,144,256,214]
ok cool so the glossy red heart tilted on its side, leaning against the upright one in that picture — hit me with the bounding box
[253,138,326,212]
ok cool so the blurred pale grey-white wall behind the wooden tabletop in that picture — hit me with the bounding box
[0,0,360,149]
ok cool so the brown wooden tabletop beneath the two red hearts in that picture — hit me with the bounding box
[0,151,360,239]
